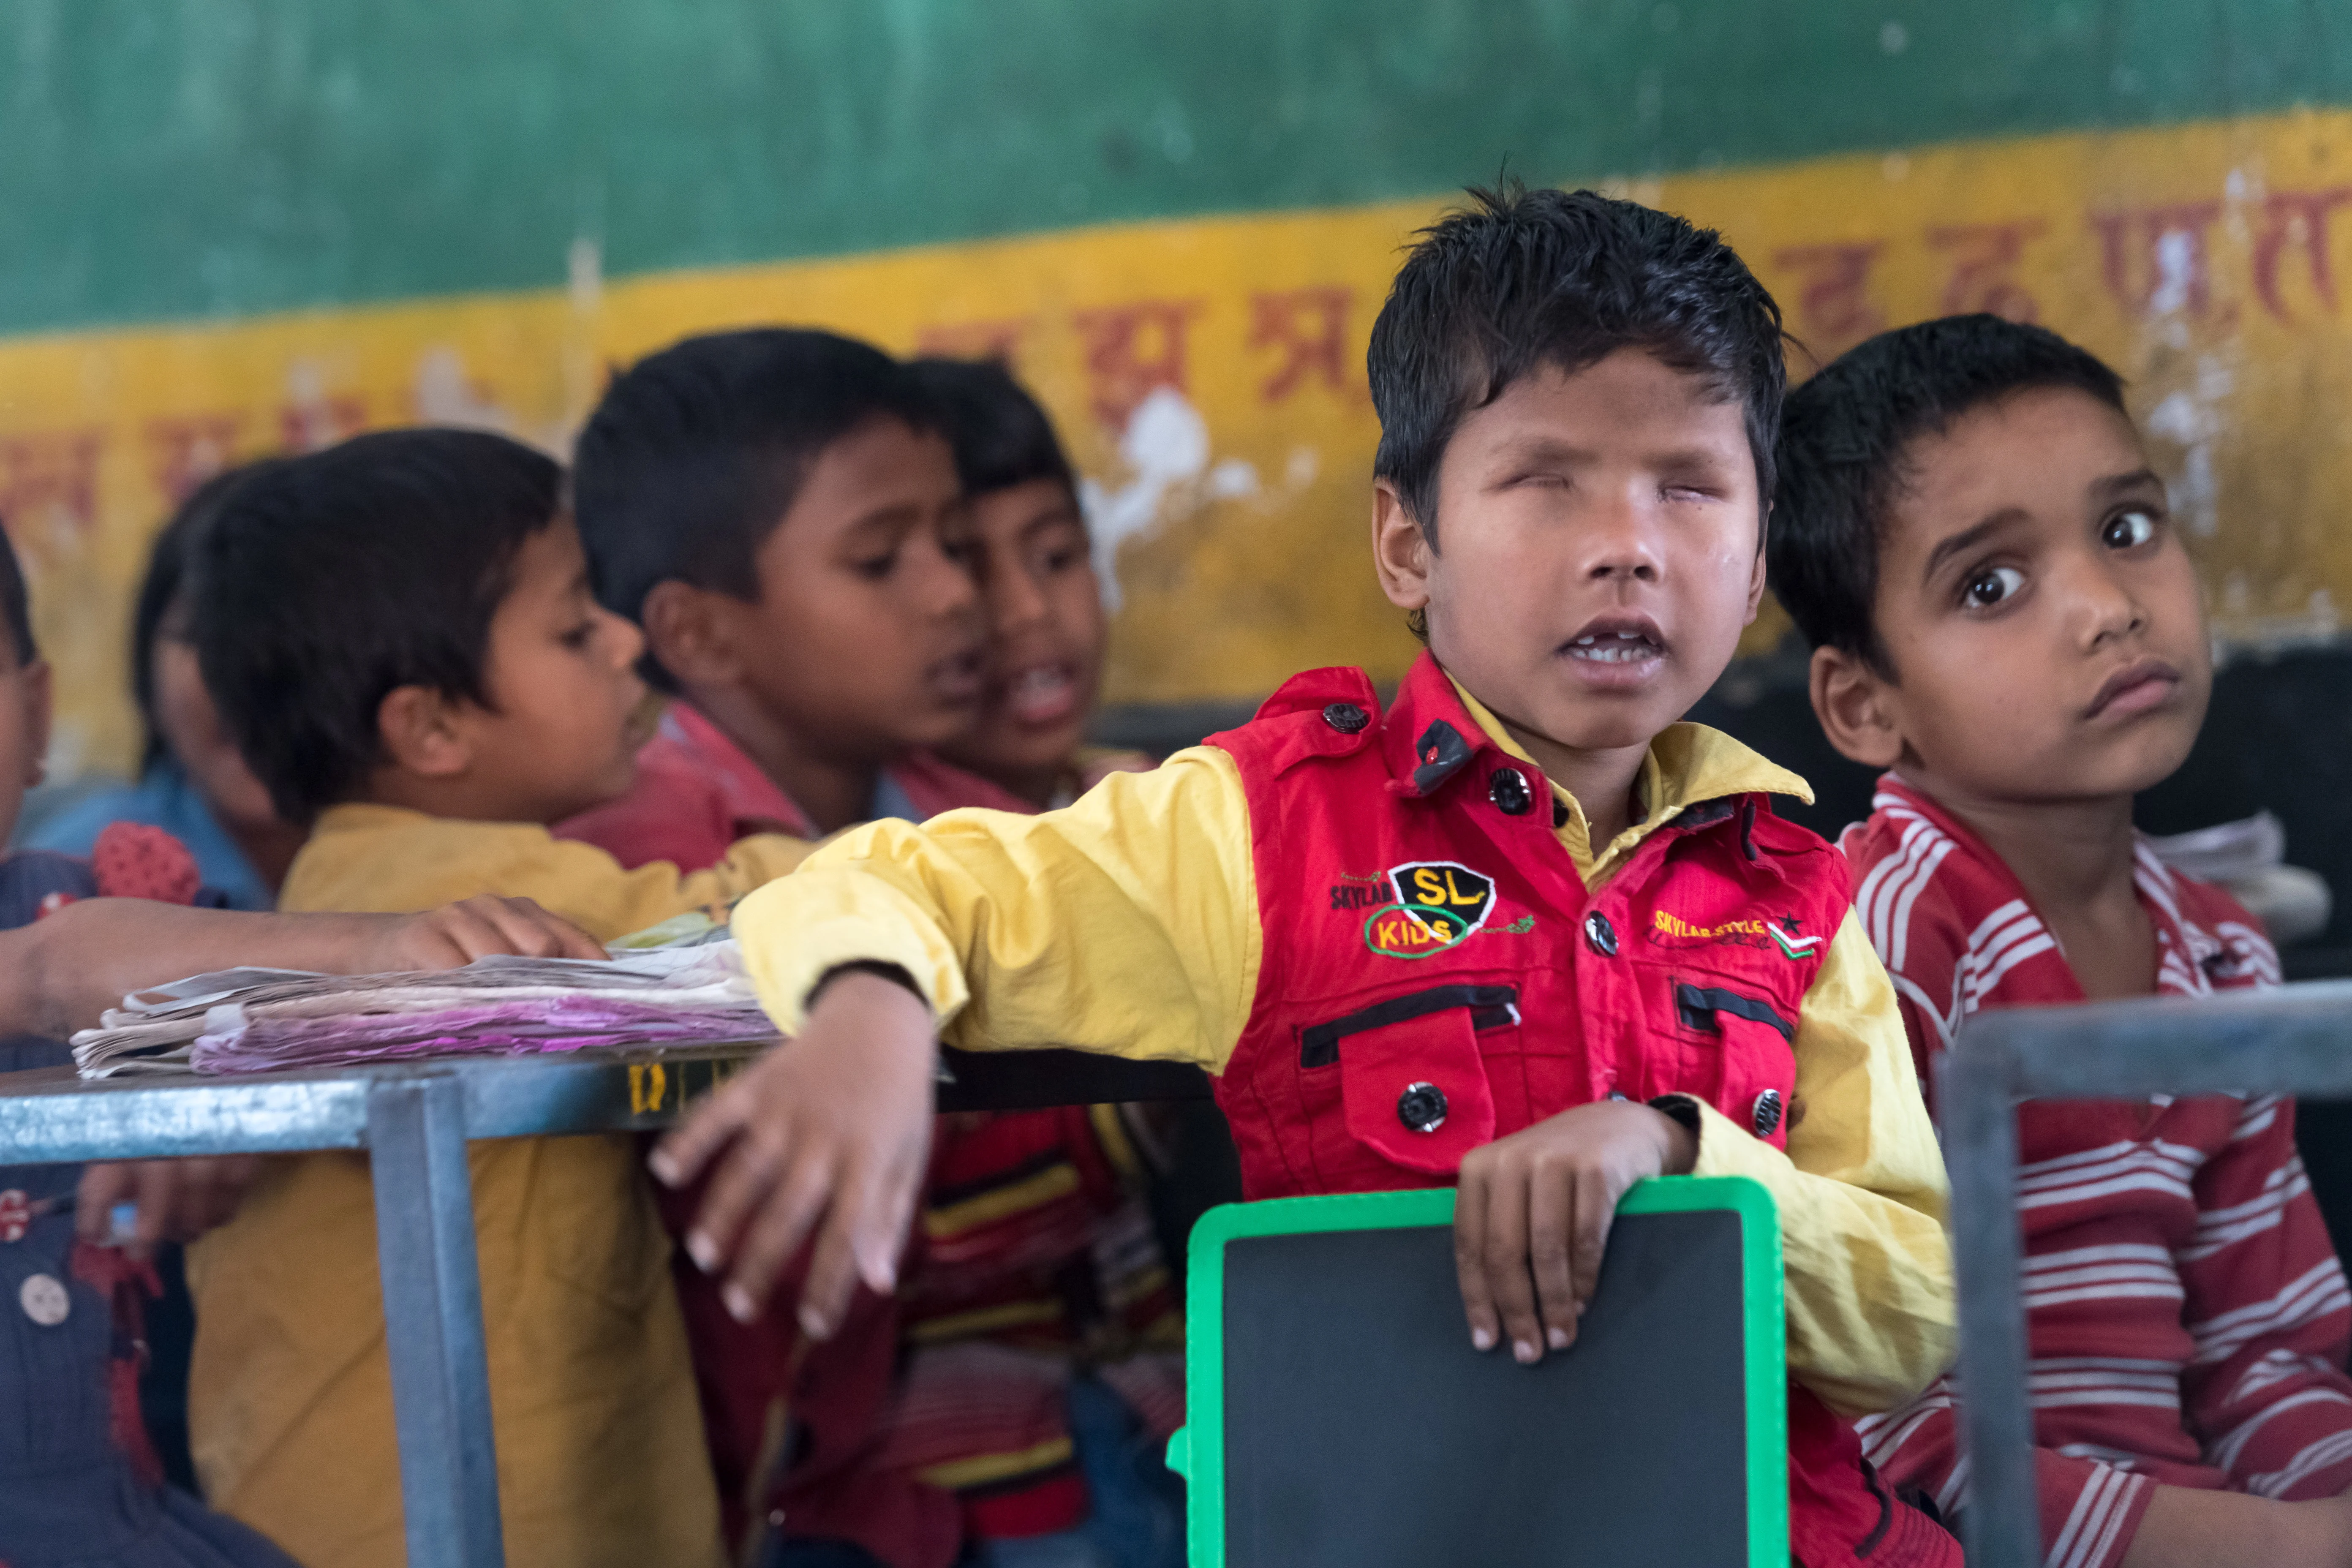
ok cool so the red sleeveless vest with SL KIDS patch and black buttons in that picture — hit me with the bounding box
[1209,656,1959,1568]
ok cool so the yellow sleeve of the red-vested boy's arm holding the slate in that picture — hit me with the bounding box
[1696,910,1955,1415]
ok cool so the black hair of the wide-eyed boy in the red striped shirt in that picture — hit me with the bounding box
[1767,315,2124,679]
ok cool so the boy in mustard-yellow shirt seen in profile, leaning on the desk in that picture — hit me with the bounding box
[188,430,807,1568]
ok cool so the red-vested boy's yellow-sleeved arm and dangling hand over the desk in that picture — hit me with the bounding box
[654,748,1260,1338]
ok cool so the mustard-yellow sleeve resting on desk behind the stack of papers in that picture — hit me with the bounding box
[278,811,811,943]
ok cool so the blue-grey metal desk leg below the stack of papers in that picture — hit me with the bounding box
[367,1077,506,1568]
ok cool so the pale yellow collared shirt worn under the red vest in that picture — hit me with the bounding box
[736,686,1955,1413]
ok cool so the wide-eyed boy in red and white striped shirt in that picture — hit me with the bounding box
[1771,315,2352,1568]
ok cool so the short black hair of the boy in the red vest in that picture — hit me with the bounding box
[1367,179,1788,548]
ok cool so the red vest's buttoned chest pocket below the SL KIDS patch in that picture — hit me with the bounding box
[1298,983,1519,1190]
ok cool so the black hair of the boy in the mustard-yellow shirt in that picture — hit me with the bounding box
[188,430,562,823]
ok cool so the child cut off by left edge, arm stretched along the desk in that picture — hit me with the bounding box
[0,514,597,1568]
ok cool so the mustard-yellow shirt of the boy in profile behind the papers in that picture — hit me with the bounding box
[188,806,809,1568]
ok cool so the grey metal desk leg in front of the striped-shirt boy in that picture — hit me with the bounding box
[1938,1048,2042,1568]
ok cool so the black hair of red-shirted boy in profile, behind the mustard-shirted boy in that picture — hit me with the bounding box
[572,327,939,691]
